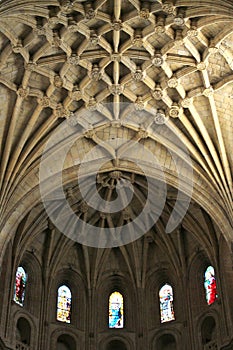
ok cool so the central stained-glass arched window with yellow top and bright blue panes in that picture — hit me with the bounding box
[109,292,124,328]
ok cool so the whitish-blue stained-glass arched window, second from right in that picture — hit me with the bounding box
[159,284,175,323]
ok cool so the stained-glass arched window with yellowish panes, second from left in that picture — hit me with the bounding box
[57,285,72,323]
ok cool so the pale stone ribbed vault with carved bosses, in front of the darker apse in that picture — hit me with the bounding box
[0,0,233,253]
